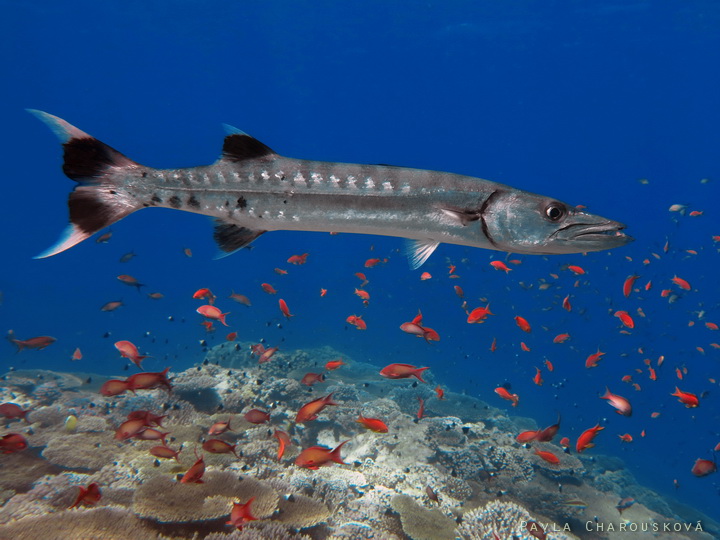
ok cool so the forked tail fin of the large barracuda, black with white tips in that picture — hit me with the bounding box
[28,109,140,259]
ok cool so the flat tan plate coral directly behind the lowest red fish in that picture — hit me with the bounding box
[133,471,279,523]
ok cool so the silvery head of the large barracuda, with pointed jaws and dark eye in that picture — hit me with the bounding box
[481,190,633,255]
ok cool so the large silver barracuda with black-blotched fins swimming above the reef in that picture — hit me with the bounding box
[29,110,632,268]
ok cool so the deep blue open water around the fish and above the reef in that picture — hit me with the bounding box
[0,0,720,518]
